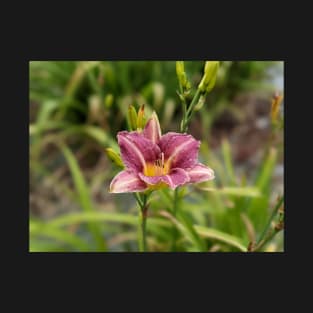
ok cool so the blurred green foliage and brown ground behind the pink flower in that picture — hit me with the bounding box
[29,61,284,252]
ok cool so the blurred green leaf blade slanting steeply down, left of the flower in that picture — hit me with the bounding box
[61,144,106,251]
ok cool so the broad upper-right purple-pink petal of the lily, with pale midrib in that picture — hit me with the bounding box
[158,132,200,169]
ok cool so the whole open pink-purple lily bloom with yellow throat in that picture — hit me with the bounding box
[110,112,214,193]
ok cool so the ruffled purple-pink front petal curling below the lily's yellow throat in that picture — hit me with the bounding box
[138,168,189,189]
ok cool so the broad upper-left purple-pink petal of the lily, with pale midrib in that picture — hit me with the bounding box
[117,131,161,172]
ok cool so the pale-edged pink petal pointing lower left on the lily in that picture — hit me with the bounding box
[110,170,147,193]
